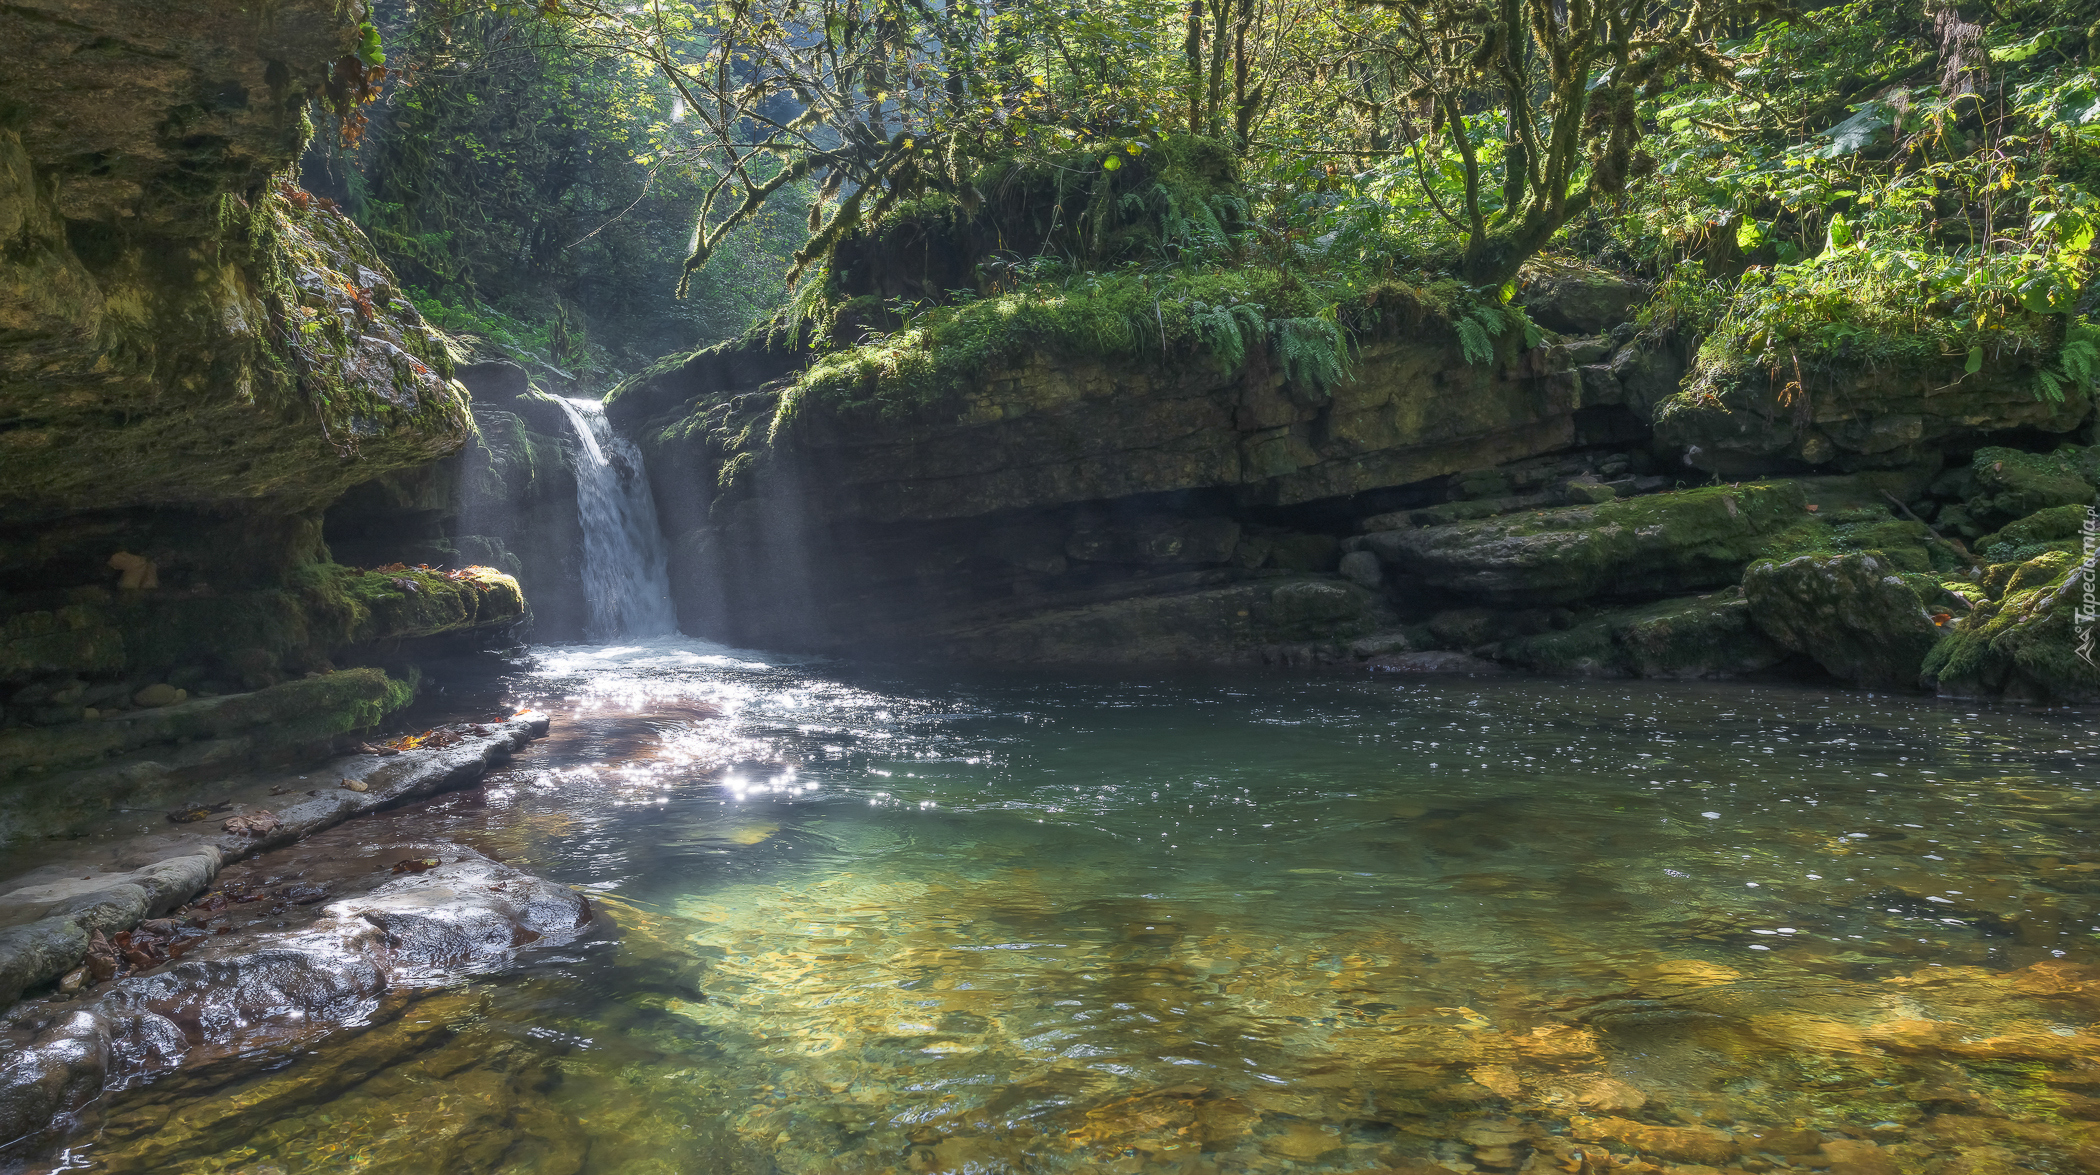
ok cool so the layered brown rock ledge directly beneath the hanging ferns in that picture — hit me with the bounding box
[730,331,1581,522]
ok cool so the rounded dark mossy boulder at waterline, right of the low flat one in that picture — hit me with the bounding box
[1743,552,1943,690]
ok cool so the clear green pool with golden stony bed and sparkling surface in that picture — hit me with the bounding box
[90,644,2100,1175]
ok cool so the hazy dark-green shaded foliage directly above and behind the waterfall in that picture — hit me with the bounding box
[305,0,800,384]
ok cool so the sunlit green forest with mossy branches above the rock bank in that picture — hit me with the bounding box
[302,0,2100,407]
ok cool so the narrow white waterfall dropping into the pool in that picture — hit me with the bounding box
[557,397,678,640]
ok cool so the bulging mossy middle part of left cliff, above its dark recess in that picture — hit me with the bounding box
[0,132,468,520]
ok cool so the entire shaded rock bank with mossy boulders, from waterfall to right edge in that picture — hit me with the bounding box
[609,255,2100,701]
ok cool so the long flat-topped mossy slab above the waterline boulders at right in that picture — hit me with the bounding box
[1365,483,1806,602]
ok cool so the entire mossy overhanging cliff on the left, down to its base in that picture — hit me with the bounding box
[0,0,541,843]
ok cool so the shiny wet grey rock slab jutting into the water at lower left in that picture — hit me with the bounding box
[0,843,590,1144]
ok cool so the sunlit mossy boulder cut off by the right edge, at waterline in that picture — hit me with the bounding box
[1924,550,2100,703]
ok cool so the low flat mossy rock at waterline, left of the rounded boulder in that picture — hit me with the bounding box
[1491,592,1789,680]
